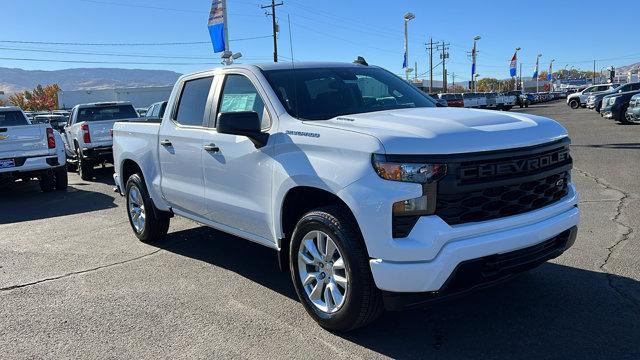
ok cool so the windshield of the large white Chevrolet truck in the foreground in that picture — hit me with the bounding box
[264,67,436,120]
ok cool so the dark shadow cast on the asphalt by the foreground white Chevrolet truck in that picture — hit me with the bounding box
[156,227,640,359]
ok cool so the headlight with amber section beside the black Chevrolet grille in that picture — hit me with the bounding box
[372,154,447,184]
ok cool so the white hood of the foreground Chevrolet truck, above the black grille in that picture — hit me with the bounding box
[308,108,567,154]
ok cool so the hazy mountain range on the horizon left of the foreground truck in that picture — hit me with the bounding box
[0,67,181,93]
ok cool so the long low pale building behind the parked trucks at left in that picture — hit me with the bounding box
[58,86,173,109]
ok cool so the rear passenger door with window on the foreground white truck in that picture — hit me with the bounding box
[158,75,213,216]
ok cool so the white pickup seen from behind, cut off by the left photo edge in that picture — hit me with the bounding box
[0,106,68,192]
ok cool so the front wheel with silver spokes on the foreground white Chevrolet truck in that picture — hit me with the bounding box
[289,206,383,331]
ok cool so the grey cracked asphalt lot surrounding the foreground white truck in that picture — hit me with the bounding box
[0,102,640,359]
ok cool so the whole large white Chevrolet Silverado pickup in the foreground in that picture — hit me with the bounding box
[113,61,580,331]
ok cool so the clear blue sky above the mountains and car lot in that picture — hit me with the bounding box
[0,0,640,82]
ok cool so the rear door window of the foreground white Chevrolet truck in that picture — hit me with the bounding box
[175,76,213,126]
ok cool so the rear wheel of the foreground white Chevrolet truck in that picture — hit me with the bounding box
[125,174,170,242]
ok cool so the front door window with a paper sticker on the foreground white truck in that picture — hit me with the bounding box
[219,74,271,129]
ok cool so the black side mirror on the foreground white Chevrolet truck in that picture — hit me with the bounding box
[216,111,269,149]
